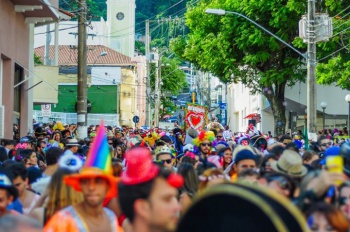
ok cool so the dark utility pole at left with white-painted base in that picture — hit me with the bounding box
[77,0,87,139]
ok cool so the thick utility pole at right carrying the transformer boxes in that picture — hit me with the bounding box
[307,0,317,133]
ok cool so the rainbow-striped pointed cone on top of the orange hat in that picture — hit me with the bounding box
[84,121,112,174]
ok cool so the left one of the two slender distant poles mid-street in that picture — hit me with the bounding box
[145,19,151,126]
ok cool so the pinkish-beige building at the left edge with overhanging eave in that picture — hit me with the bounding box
[0,0,59,139]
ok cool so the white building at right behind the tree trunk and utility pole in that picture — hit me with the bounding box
[227,82,349,133]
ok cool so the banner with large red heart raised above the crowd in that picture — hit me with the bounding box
[185,103,208,131]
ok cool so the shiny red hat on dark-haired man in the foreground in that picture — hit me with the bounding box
[121,147,159,185]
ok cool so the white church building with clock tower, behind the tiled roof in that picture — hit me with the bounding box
[34,0,136,57]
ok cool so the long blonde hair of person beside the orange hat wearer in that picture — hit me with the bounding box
[45,168,84,221]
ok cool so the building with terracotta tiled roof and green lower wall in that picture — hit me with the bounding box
[35,45,138,126]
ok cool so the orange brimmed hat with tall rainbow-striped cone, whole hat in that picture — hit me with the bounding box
[64,122,118,197]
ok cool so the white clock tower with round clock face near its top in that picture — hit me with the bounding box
[107,0,136,57]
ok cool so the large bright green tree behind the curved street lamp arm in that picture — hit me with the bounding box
[171,0,348,135]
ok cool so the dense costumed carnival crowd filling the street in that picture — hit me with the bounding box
[0,122,350,232]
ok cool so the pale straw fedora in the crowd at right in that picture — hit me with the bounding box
[271,150,307,177]
